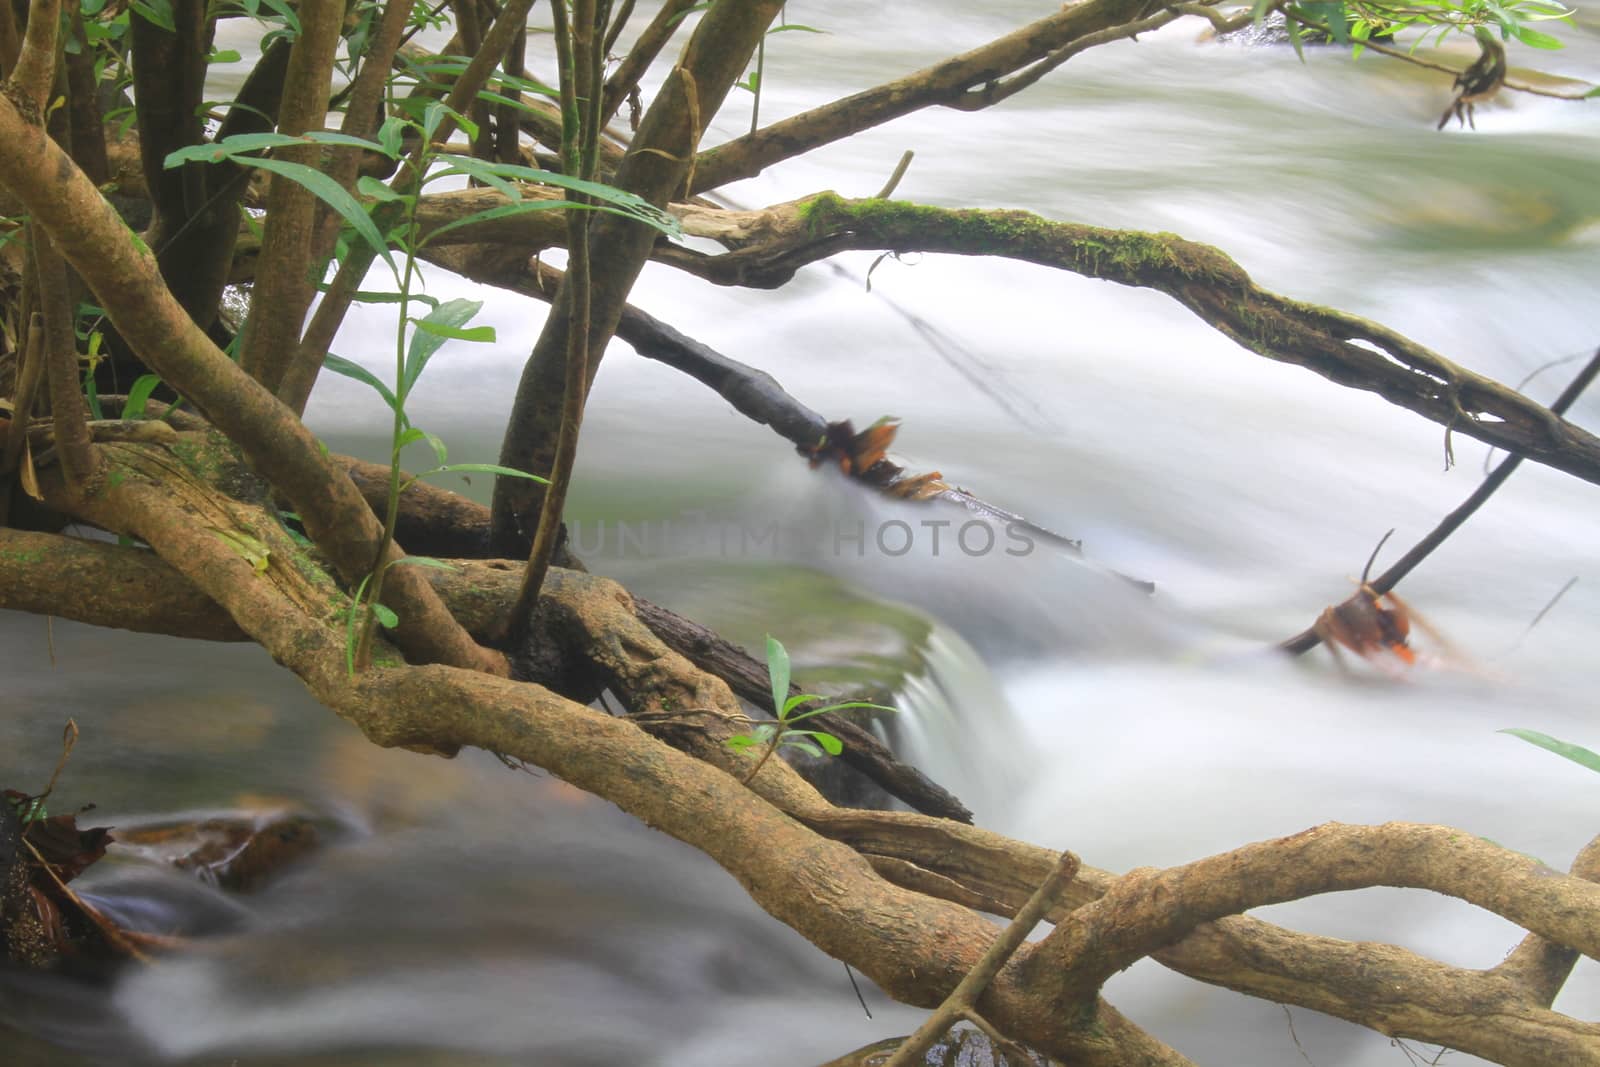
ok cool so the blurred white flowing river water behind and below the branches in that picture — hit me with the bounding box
[0,0,1600,1067]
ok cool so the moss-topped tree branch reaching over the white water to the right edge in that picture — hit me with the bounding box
[659,194,1600,483]
